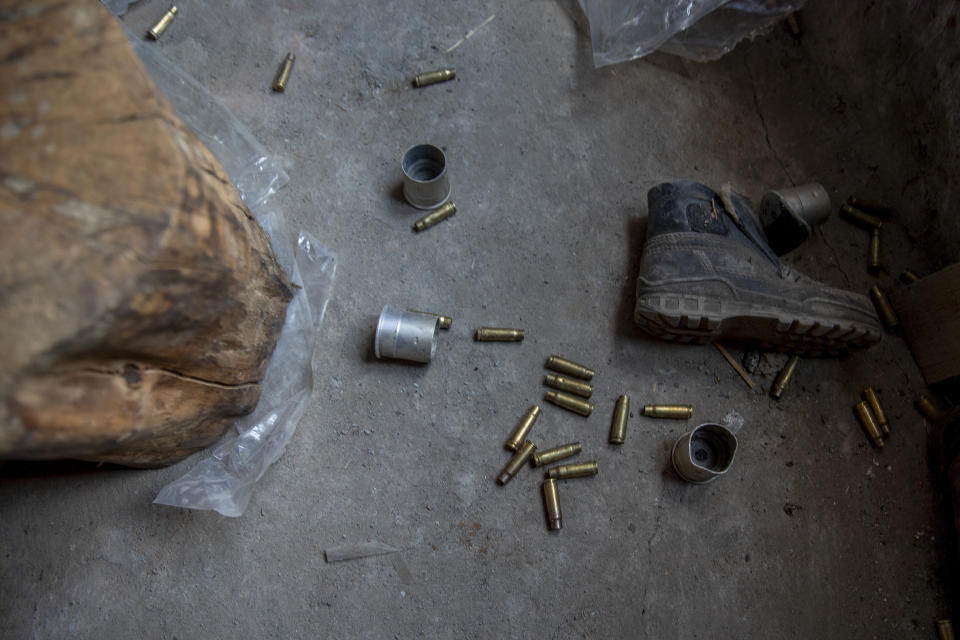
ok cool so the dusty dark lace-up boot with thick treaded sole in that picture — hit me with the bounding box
[634,181,882,356]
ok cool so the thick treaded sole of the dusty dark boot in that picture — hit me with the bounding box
[634,294,881,357]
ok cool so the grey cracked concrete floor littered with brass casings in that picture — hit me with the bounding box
[0,0,955,638]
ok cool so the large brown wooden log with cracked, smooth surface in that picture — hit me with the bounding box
[0,0,292,466]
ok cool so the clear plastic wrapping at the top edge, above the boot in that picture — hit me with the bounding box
[579,0,805,67]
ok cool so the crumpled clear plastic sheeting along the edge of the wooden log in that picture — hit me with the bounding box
[106,13,336,517]
